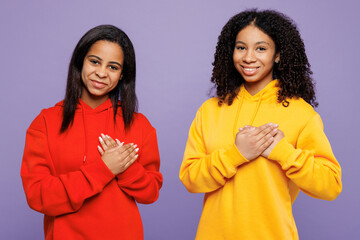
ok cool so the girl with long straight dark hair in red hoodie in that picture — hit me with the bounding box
[21,25,162,240]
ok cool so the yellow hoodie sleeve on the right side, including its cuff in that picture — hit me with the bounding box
[269,114,342,200]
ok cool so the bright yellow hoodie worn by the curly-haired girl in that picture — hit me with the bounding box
[180,80,342,240]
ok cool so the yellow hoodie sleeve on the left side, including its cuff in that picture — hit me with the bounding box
[179,108,248,193]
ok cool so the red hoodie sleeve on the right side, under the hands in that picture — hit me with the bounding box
[117,126,163,204]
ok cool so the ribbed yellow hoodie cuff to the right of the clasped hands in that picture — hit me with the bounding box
[269,138,296,167]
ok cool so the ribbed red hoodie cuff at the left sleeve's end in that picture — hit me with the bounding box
[80,160,115,189]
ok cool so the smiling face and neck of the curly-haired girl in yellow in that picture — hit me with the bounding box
[233,25,280,95]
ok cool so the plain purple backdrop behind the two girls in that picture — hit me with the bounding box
[0,0,360,240]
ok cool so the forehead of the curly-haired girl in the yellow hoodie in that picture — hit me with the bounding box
[236,25,274,45]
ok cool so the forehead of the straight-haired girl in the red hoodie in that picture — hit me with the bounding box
[87,40,124,61]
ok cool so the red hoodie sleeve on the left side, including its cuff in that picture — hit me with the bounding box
[20,114,115,216]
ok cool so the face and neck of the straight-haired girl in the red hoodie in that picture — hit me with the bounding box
[81,40,124,108]
